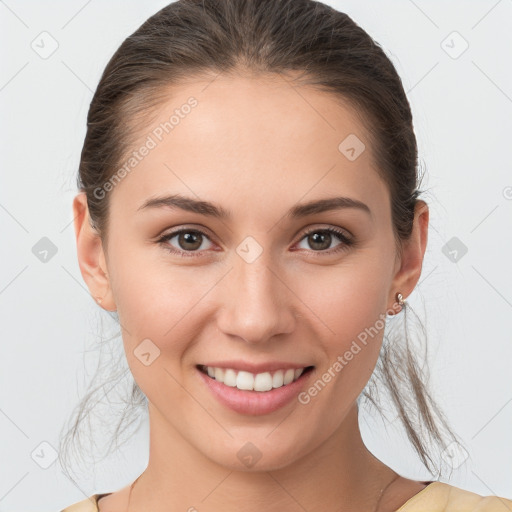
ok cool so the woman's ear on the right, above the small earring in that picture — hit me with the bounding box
[389,200,429,307]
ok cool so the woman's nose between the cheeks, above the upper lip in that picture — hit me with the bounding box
[217,251,299,344]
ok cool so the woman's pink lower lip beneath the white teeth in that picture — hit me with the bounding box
[197,369,312,416]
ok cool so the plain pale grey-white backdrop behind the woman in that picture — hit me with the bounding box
[0,0,512,512]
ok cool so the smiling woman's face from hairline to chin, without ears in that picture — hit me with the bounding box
[76,72,426,469]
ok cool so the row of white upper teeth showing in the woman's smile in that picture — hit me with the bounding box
[203,366,304,391]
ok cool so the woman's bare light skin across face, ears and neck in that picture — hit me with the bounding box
[73,75,429,512]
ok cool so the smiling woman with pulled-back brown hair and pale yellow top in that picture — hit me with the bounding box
[59,0,512,512]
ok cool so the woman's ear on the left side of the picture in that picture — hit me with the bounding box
[73,192,116,311]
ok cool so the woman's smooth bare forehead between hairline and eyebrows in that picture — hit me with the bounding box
[107,71,388,222]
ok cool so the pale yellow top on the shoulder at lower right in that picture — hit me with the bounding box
[396,481,512,512]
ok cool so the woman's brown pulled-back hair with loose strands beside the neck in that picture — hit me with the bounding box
[59,0,459,480]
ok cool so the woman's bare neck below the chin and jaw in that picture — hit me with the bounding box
[129,404,398,512]
